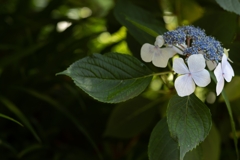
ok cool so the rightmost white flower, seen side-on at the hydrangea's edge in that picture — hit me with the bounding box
[214,54,234,95]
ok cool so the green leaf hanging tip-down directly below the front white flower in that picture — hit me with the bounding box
[167,94,212,160]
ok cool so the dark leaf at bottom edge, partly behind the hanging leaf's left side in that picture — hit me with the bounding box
[148,118,179,160]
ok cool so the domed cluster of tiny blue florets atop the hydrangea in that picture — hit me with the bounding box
[163,26,224,63]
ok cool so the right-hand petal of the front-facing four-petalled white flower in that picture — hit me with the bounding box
[191,69,211,87]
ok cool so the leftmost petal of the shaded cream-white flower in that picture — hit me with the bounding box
[141,43,155,62]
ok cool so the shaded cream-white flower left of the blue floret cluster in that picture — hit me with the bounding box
[141,36,176,68]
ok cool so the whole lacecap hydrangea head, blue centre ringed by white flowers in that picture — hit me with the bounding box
[141,26,234,97]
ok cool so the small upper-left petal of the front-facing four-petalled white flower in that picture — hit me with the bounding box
[173,58,189,74]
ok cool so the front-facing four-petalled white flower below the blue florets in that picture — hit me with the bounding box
[173,54,211,97]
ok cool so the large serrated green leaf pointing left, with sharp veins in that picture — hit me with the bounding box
[59,53,152,103]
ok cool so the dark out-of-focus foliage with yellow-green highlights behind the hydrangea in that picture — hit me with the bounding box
[0,0,240,160]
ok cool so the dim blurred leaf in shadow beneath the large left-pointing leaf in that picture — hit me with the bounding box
[104,97,161,138]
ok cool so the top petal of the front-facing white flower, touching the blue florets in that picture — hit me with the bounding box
[187,54,206,73]
